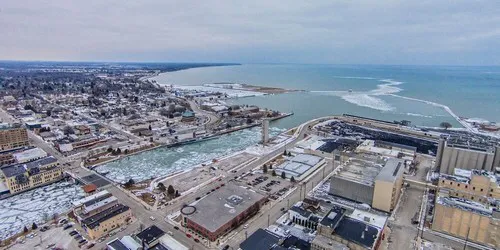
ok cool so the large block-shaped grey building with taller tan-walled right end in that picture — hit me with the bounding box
[330,158,404,212]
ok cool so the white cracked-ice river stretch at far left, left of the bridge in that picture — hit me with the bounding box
[0,182,84,240]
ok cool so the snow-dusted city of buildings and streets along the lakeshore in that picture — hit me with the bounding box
[0,61,500,250]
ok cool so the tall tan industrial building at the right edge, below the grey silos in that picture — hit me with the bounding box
[431,168,500,248]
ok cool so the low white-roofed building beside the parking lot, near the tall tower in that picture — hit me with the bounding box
[275,154,326,180]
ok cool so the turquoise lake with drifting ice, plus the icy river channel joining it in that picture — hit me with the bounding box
[98,65,500,182]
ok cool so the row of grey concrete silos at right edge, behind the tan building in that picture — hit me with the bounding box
[436,139,500,174]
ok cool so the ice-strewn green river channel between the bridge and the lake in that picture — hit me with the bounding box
[95,127,285,183]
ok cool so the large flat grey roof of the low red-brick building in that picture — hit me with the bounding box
[185,184,264,232]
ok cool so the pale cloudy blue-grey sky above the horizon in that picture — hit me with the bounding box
[0,0,500,65]
